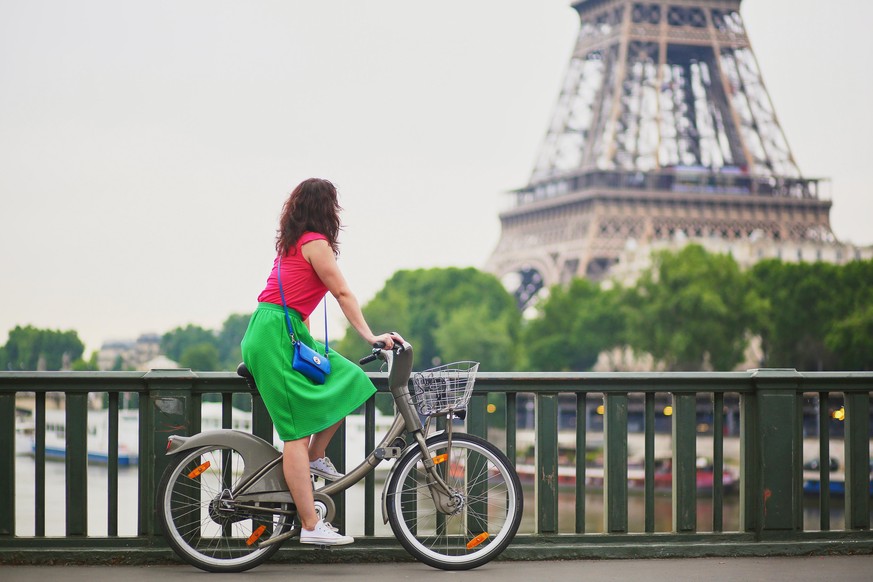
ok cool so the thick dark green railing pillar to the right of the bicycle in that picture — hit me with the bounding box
[741,369,803,534]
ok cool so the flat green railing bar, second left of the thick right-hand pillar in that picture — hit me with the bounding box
[672,393,697,532]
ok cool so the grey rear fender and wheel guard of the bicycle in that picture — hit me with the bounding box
[167,429,288,495]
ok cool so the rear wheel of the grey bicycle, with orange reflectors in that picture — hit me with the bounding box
[157,445,293,572]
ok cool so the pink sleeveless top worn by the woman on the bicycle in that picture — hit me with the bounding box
[258,232,327,320]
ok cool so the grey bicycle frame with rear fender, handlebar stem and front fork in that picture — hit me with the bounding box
[167,343,455,545]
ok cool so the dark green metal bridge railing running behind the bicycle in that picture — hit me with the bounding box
[0,369,873,562]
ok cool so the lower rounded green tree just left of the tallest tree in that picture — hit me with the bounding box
[523,279,625,372]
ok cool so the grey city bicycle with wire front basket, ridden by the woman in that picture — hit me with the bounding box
[157,342,523,572]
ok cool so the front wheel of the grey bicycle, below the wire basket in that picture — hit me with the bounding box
[386,433,523,570]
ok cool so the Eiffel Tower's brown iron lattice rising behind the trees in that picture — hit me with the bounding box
[486,0,836,308]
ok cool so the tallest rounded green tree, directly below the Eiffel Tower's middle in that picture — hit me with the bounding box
[628,244,763,370]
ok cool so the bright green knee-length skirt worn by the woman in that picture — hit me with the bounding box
[241,303,376,441]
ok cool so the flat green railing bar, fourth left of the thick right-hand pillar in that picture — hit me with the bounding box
[603,392,628,534]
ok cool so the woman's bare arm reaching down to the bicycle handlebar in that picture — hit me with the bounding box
[302,239,403,350]
